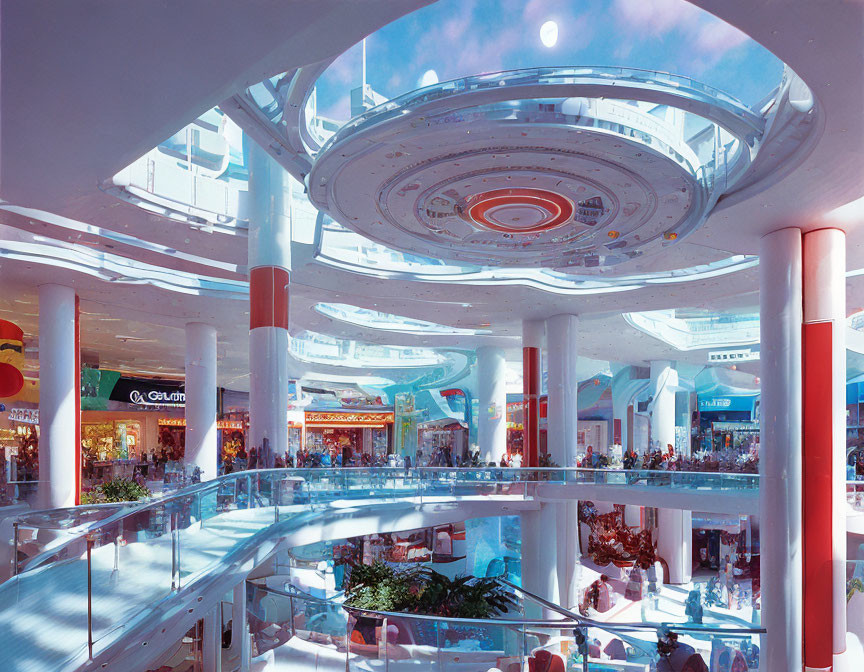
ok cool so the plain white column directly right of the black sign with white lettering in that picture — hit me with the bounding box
[186,322,219,481]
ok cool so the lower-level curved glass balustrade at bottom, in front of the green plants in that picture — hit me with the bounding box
[247,582,765,672]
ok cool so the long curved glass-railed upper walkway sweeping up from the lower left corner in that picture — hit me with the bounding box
[0,468,758,672]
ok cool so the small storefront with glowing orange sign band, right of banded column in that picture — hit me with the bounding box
[304,411,394,466]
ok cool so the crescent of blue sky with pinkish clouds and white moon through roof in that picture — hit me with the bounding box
[312,0,783,123]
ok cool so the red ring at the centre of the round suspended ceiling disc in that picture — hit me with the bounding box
[466,189,574,234]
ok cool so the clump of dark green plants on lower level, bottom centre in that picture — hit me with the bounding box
[345,562,516,618]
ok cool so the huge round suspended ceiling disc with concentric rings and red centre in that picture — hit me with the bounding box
[308,66,759,270]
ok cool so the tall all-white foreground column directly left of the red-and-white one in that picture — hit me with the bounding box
[759,229,803,670]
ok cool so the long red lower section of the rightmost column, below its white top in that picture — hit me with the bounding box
[802,322,834,668]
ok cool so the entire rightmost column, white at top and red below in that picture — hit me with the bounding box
[800,229,846,671]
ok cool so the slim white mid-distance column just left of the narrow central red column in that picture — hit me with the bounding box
[477,346,507,464]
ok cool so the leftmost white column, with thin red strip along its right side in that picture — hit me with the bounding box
[39,285,80,508]
